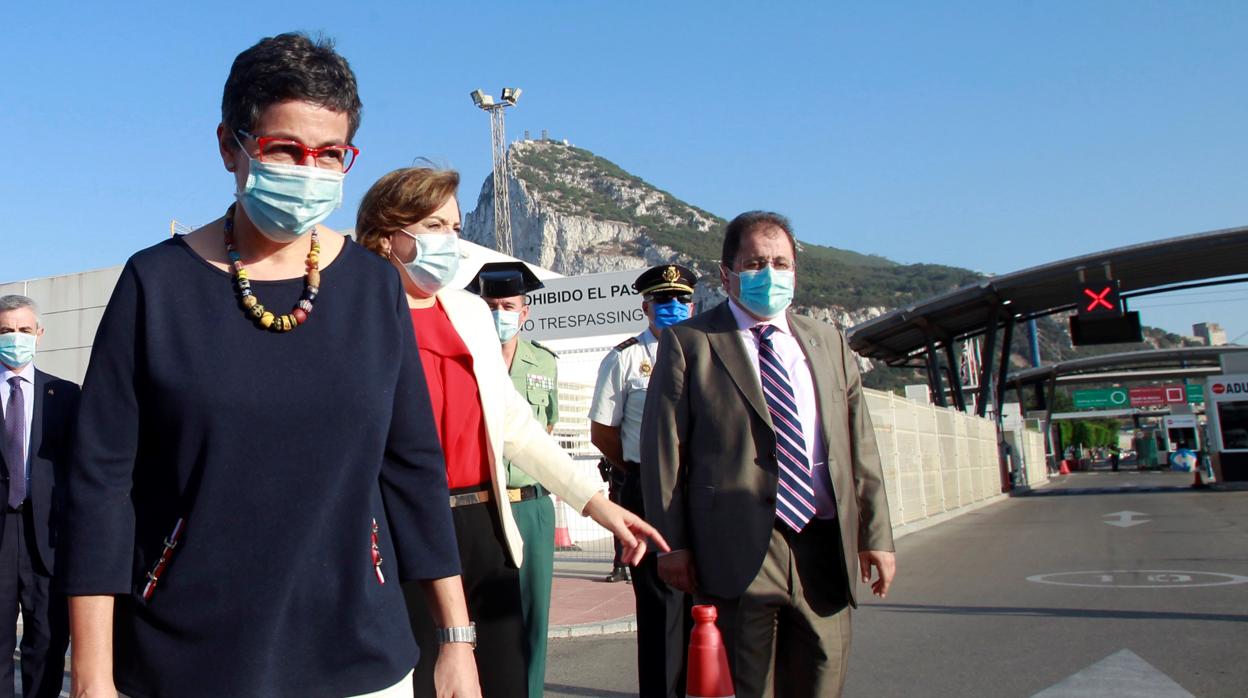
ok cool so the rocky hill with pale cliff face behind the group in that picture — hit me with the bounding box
[463,140,1182,388]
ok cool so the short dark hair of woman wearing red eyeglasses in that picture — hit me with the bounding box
[221,32,363,142]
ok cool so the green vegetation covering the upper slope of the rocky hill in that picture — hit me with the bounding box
[512,142,981,308]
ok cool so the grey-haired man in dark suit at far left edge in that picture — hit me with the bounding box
[0,296,79,698]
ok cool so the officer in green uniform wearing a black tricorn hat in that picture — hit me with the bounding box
[467,262,559,698]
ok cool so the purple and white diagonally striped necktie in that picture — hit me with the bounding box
[750,325,815,532]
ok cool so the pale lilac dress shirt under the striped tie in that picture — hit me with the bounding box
[728,298,836,518]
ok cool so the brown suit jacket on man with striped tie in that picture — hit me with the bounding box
[641,301,892,603]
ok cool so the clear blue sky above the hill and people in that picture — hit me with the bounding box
[0,0,1248,341]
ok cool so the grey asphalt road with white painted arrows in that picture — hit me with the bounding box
[547,469,1248,698]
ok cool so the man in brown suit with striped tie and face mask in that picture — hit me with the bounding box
[641,211,896,698]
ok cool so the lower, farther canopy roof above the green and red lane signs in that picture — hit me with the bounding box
[1006,346,1248,385]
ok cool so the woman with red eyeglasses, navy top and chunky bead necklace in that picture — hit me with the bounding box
[57,34,479,698]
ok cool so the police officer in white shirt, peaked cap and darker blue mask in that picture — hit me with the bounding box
[589,265,698,697]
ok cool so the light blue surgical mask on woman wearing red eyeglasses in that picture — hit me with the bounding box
[235,136,346,242]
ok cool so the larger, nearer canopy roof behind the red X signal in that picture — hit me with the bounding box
[846,227,1248,362]
